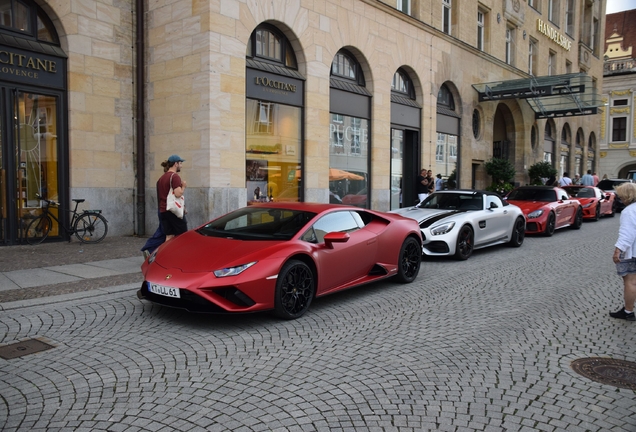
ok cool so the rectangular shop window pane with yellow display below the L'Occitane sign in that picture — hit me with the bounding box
[245,99,301,204]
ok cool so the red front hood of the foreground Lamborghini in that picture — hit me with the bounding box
[153,230,289,273]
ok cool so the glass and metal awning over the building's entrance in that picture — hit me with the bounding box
[473,73,602,119]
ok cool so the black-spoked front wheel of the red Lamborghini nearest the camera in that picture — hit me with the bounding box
[274,260,316,320]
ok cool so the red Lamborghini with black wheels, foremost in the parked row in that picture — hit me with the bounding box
[137,203,422,319]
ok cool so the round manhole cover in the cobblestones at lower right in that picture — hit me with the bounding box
[570,357,636,390]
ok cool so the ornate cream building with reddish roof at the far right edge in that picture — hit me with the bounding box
[599,9,636,178]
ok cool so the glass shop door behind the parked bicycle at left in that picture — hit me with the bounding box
[13,90,60,237]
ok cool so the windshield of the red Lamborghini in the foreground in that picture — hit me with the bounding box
[197,207,316,240]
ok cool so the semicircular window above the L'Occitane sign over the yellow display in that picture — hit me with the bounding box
[246,24,298,69]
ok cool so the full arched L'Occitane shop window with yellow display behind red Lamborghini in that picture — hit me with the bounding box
[245,24,305,205]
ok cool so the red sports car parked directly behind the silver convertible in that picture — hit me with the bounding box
[506,186,583,236]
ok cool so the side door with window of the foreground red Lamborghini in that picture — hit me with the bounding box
[301,210,378,294]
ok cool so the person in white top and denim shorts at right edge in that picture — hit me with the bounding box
[610,183,636,321]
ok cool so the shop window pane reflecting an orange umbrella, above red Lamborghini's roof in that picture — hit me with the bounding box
[329,114,369,208]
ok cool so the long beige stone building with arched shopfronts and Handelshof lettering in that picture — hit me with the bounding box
[0,0,605,244]
